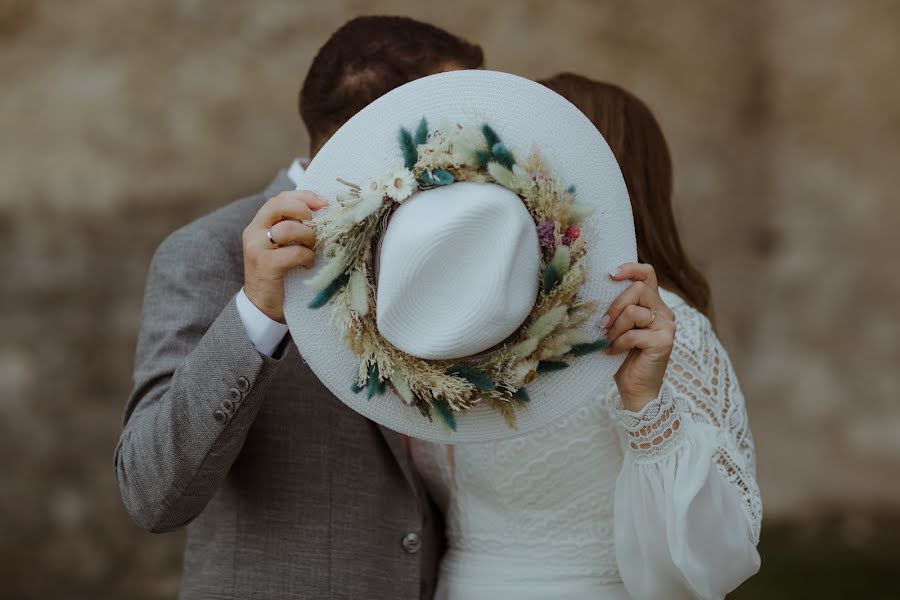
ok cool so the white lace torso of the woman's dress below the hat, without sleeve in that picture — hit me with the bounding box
[412,402,622,583]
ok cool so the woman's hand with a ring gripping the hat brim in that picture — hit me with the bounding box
[600,263,675,412]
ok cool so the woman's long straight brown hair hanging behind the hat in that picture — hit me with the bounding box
[539,73,712,317]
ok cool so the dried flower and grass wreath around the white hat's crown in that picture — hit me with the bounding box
[306,118,606,431]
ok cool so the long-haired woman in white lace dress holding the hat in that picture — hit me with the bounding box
[410,74,762,600]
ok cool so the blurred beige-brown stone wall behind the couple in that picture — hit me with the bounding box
[0,0,900,598]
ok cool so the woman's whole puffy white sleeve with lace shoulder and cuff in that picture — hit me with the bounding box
[612,304,762,600]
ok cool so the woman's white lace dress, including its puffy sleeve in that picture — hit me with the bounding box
[411,290,762,600]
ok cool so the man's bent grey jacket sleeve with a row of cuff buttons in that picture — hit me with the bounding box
[115,227,278,532]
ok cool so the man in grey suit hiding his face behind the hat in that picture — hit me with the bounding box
[115,17,482,599]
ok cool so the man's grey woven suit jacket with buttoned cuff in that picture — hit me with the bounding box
[115,172,444,599]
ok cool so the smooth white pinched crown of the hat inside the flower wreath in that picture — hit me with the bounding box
[376,182,540,360]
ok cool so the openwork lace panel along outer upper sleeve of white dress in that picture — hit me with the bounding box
[666,304,762,544]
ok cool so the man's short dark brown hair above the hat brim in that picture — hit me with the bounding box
[300,16,484,150]
